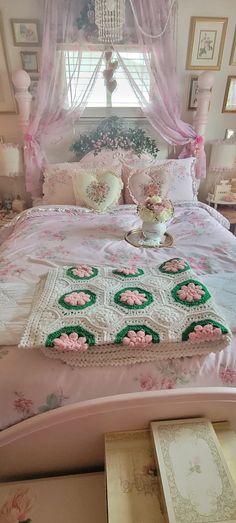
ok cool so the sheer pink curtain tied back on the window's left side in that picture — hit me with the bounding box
[24,0,102,197]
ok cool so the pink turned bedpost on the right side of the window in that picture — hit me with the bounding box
[193,71,215,140]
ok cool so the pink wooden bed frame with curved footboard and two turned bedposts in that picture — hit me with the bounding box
[0,71,226,480]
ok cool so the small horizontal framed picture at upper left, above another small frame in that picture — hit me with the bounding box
[11,18,40,47]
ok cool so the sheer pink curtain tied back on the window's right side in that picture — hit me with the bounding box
[117,0,206,178]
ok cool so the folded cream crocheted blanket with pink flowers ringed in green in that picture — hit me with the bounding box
[19,258,231,367]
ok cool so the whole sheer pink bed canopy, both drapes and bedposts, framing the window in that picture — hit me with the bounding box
[13,0,213,198]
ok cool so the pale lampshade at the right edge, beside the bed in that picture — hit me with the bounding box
[209,141,236,171]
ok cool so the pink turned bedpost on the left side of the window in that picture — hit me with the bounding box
[12,69,32,138]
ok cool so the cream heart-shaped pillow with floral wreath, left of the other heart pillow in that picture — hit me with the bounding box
[73,169,123,211]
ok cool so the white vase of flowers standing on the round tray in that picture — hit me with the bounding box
[138,195,174,245]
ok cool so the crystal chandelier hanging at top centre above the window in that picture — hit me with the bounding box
[95,0,125,43]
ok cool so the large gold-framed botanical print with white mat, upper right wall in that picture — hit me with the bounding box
[186,16,228,71]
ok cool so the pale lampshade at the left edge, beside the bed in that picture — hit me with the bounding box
[0,143,23,177]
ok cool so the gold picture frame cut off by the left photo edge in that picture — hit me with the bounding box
[0,13,17,114]
